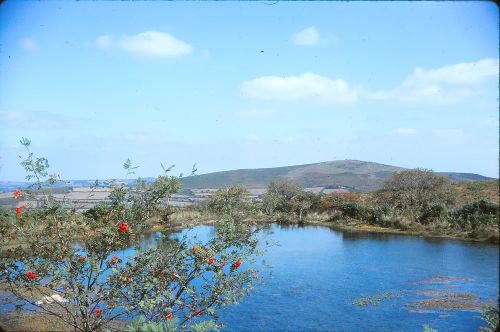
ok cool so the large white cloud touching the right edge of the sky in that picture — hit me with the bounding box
[368,59,498,105]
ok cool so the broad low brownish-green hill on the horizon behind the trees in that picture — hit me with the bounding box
[182,160,492,191]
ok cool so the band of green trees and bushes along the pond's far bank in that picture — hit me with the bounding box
[201,168,499,241]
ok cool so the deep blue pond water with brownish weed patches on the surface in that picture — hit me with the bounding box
[0,225,499,332]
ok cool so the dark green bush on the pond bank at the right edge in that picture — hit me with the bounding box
[449,199,499,229]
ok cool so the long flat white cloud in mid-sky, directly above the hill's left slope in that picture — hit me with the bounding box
[240,73,358,104]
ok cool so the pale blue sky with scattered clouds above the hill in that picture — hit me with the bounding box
[0,1,499,180]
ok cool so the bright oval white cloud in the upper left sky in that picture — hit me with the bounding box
[95,31,193,58]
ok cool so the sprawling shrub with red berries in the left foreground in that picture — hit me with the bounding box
[0,139,268,331]
